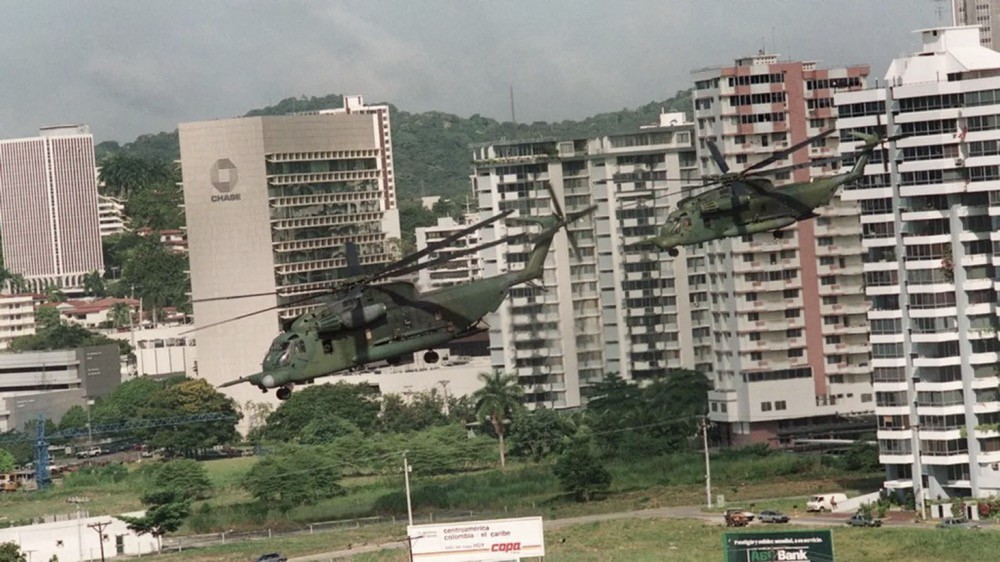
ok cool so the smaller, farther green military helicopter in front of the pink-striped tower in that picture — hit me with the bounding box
[635,129,901,256]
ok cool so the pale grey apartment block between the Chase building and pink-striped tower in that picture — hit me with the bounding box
[473,114,710,408]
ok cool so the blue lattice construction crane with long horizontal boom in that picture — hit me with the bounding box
[0,412,236,490]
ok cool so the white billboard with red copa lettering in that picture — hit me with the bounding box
[406,517,545,562]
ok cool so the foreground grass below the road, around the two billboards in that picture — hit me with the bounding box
[146,519,1000,562]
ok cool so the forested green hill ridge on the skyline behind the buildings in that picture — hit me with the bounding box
[96,91,691,200]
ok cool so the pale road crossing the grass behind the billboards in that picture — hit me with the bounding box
[288,505,931,562]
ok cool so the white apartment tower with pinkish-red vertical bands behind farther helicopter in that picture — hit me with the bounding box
[692,52,874,445]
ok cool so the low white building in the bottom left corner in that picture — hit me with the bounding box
[0,512,157,562]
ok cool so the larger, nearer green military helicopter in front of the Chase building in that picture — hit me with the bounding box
[213,196,596,400]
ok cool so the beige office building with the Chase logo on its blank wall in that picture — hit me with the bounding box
[180,97,399,400]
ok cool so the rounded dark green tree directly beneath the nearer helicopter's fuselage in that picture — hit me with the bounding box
[262,382,379,443]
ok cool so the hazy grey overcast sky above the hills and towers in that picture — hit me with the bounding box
[0,0,951,142]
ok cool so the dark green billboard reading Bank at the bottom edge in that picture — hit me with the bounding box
[722,529,833,562]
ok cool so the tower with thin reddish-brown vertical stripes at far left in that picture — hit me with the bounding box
[0,125,104,292]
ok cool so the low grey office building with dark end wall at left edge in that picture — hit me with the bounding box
[0,344,122,433]
